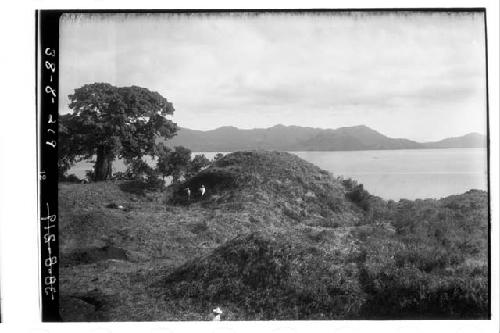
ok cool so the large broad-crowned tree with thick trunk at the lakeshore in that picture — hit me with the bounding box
[59,83,177,180]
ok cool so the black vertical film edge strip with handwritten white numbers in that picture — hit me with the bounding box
[36,11,61,322]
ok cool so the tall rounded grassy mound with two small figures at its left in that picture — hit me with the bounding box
[171,151,363,227]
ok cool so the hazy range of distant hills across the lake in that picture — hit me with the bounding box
[162,125,486,152]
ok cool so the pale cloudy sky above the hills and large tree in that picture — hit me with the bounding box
[59,13,486,141]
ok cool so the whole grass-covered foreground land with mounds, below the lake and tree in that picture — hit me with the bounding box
[59,152,489,321]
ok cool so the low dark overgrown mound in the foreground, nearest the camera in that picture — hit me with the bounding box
[161,233,362,320]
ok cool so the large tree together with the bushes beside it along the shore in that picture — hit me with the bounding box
[58,83,228,184]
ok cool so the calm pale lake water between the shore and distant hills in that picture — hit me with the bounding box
[69,148,487,200]
